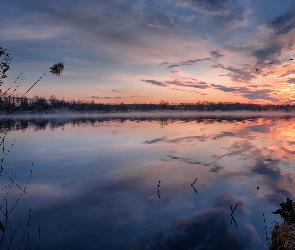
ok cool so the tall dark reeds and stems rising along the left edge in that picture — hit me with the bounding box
[0,47,64,250]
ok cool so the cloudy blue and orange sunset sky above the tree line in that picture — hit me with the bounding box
[0,0,295,104]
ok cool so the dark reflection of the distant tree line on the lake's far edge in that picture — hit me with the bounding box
[0,115,294,132]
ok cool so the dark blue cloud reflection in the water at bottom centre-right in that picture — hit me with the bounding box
[137,193,262,250]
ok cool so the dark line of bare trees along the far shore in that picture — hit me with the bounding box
[0,94,295,114]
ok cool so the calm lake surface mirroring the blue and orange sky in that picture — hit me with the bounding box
[0,114,295,250]
